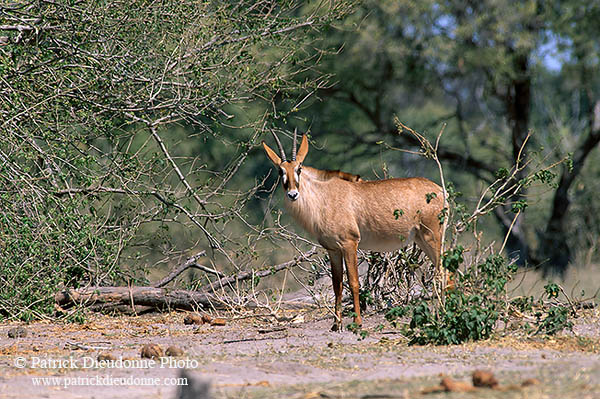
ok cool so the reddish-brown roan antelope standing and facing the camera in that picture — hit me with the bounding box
[262,132,444,331]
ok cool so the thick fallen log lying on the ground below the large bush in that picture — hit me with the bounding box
[54,287,225,310]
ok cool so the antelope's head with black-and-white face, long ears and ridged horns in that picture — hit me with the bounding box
[262,131,308,201]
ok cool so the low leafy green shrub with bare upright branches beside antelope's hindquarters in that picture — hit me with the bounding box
[365,123,572,345]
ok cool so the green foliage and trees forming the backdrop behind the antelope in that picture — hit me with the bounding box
[0,0,600,319]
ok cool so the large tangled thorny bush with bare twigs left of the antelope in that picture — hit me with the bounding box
[0,0,352,320]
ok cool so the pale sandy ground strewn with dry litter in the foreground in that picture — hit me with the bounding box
[0,310,600,399]
